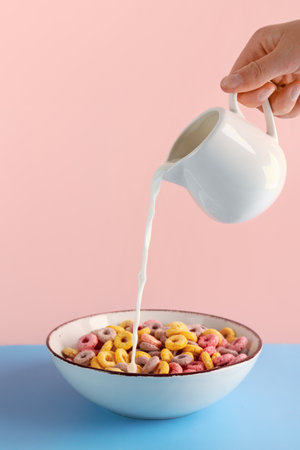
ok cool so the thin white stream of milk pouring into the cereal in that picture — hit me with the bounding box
[128,163,172,373]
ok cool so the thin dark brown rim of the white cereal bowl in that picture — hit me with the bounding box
[46,308,263,378]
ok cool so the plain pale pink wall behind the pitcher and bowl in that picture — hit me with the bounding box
[0,0,300,344]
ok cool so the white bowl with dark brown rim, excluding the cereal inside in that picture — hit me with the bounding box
[47,309,262,419]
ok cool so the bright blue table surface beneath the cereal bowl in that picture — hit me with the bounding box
[0,344,300,450]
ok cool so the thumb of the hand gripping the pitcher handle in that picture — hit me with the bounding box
[221,50,286,93]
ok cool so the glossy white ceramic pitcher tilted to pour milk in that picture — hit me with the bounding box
[164,94,286,223]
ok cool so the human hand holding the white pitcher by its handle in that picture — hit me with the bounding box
[221,20,300,118]
